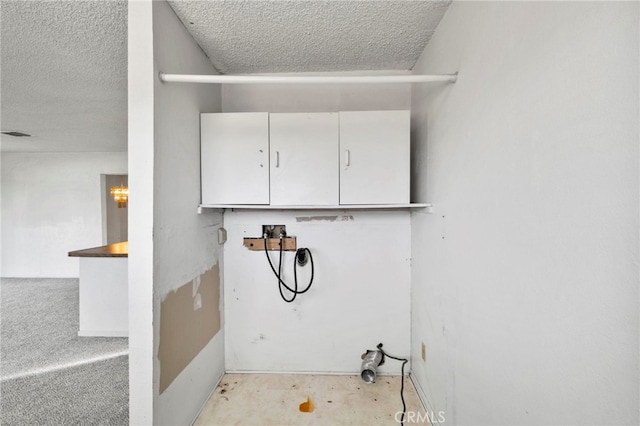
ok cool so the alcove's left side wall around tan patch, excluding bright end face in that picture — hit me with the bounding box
[153,2,224,425]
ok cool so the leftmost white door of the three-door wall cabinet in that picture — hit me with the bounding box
[200,112,269,204]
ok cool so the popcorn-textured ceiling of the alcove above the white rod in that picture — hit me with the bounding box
[167,0,450,74]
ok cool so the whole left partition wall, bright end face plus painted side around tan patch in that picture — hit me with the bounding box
[128,1,224,425]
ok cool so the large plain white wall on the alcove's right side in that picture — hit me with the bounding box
[412,2,639,425]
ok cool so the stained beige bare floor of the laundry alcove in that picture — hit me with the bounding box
[194,374,429,426]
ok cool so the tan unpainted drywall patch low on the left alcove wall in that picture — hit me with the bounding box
[158,264,220,393]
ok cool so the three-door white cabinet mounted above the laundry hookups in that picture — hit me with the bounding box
[200,111,410,208]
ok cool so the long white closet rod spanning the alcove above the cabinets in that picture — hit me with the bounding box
[160,72,458,84]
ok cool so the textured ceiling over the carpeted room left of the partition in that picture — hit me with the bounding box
[0,0,127,151]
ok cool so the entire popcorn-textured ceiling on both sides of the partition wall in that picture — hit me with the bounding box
[0,0,450,152]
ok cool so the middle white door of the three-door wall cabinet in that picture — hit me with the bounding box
[269,113,338,206]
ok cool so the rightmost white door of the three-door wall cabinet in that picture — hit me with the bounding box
[340,111,410,204]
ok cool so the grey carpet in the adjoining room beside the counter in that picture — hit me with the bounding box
[0,278,129,425]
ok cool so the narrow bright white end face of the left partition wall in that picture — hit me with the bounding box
[127,0,157,425]
